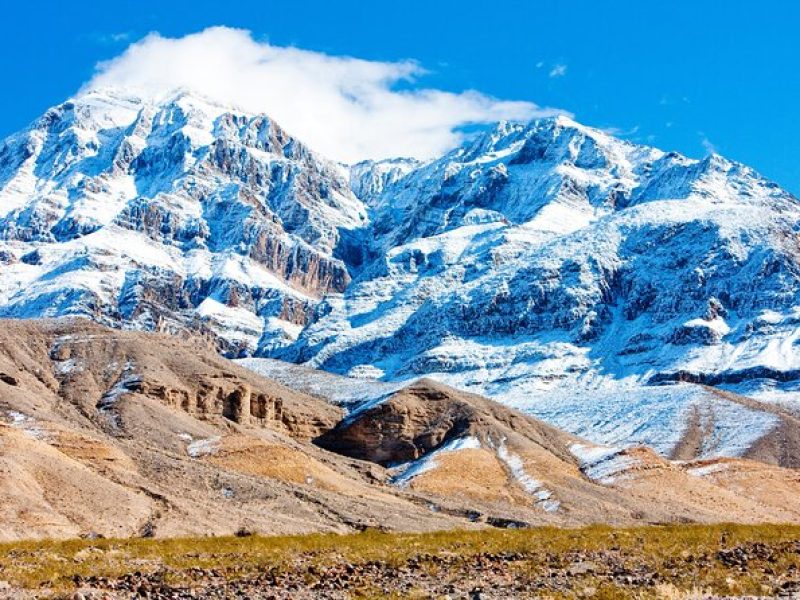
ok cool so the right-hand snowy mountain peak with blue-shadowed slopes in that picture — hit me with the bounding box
[279,117,800,455]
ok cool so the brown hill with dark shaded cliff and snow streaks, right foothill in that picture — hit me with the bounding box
[316,379,800,524]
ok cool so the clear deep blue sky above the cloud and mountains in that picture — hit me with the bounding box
[0,0,800,194]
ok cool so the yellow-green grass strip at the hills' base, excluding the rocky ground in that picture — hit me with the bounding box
[0,525,800,598]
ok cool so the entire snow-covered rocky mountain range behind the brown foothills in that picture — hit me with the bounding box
[0,91,800,455]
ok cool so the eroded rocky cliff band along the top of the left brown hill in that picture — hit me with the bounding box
[39,322,341,439]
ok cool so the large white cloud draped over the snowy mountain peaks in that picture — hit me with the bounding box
[83,27,563,162]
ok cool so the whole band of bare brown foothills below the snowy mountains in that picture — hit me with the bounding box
[0,320,800,540]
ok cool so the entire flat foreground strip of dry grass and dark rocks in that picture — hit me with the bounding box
[0,525,800,598]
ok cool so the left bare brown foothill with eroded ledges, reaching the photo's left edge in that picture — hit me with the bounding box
[0,320,469,540]
